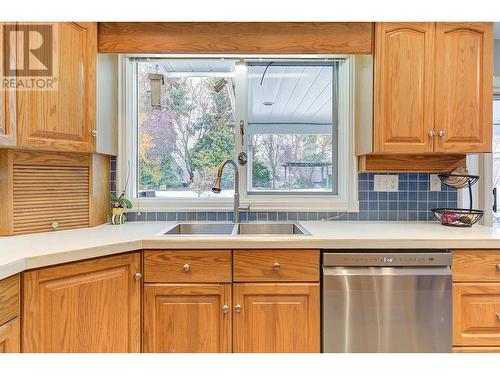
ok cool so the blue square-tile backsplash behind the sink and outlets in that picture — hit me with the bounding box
[110,157,458,221]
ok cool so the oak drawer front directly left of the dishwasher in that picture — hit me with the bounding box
[233,250,319,282]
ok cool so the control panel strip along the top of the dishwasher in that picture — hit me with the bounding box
[323,251,451,267]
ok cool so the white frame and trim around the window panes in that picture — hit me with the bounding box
[116,55,359,212]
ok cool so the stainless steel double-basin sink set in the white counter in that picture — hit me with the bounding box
[160,222,311,236]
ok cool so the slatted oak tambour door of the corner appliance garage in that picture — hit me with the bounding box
[12,153,90,234]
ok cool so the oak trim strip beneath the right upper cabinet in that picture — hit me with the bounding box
[358,154,466,173]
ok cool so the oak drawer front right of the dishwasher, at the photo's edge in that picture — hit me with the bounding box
[452,250,500,282]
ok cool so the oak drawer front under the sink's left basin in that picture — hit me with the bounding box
[144,250,231,283]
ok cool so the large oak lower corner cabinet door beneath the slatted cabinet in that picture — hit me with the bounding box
[22,252,141,353]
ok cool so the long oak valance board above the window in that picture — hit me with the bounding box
[97,22,373,54]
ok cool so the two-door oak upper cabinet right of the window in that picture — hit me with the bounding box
[370,22,493,154]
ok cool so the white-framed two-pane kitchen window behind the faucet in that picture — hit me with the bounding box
[118,56,357,211]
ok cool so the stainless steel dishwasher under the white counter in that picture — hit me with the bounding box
[322,250,451,353]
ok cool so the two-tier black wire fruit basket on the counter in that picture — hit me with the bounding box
[431,172,484,227]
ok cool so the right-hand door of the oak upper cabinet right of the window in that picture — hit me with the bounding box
[435,22,493,153]
